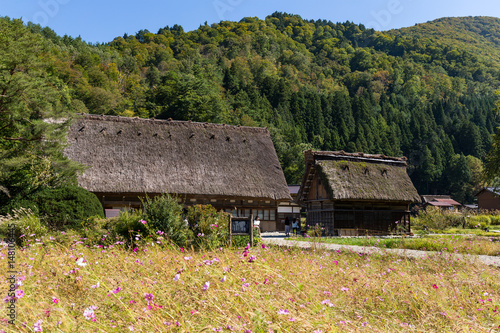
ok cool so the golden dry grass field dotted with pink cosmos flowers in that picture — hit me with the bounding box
[0,233,500,332]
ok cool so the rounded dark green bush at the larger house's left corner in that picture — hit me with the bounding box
[28,186,104,229]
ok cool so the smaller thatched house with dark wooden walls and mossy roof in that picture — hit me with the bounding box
[298,151,420,236]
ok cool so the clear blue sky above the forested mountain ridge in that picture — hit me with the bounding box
[0,0,500,43]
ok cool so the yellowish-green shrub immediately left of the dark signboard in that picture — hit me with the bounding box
[186,205,229,249]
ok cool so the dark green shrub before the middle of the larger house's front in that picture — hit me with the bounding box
[142,193,193,246]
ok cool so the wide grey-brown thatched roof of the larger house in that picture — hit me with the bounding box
[65,115,290,200]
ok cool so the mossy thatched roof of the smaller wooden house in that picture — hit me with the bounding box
[299,151,420,202]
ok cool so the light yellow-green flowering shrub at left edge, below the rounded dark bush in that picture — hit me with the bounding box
[0,208,47,244]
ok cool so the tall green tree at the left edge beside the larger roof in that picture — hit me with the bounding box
[0,19,83,203]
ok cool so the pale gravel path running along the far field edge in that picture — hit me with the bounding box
[262,235,500,267]
